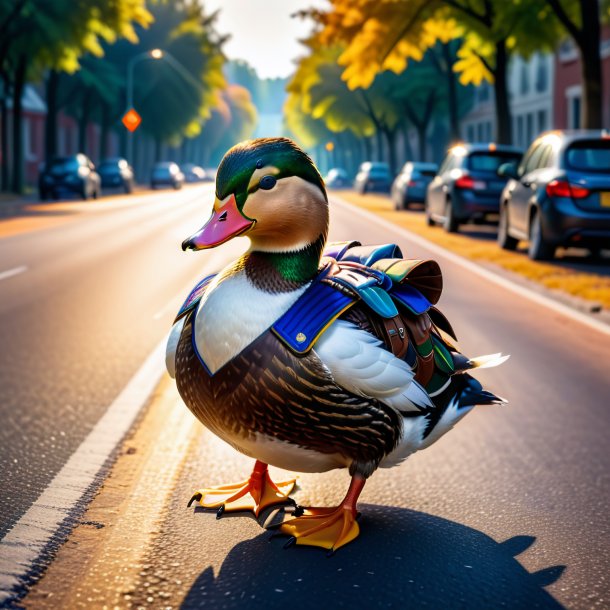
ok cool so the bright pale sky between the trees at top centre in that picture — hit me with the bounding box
[204,0,327,78]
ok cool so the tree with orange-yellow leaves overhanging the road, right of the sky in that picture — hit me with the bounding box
[304,0,556,143]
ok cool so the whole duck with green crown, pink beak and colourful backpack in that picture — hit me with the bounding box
[166,138,507,553]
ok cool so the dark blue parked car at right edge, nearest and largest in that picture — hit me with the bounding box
[498,130,610,260]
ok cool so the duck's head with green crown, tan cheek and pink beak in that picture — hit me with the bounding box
[182,138,328,252]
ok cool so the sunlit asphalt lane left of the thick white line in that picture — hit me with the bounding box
[0,185,241,538]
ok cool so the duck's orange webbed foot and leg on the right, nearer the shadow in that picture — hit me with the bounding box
[279,474,366,553]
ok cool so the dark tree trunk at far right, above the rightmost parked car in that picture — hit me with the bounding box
[577,0,603,129]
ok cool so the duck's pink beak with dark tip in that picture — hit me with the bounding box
[182,195,256,250]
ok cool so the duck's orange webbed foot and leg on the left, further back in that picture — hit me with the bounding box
[188,460,296,519]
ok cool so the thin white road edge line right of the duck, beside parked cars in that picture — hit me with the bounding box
[332,197,610,336]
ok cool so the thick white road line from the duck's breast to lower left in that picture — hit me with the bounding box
[0,337,167,605]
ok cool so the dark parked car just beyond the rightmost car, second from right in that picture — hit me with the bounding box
[425,143,523,233]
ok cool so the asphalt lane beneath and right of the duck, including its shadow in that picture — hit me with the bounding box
[126,191,610,609]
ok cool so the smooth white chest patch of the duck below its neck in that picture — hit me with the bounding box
[194,271,307,373]
